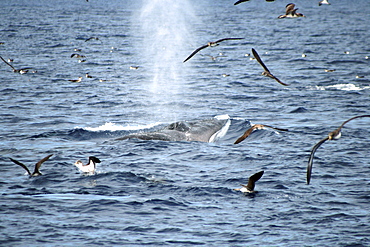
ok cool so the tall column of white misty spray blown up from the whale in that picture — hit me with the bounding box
[139,0,194,120]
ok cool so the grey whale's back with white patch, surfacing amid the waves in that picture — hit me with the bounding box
[116,115,231,142]
